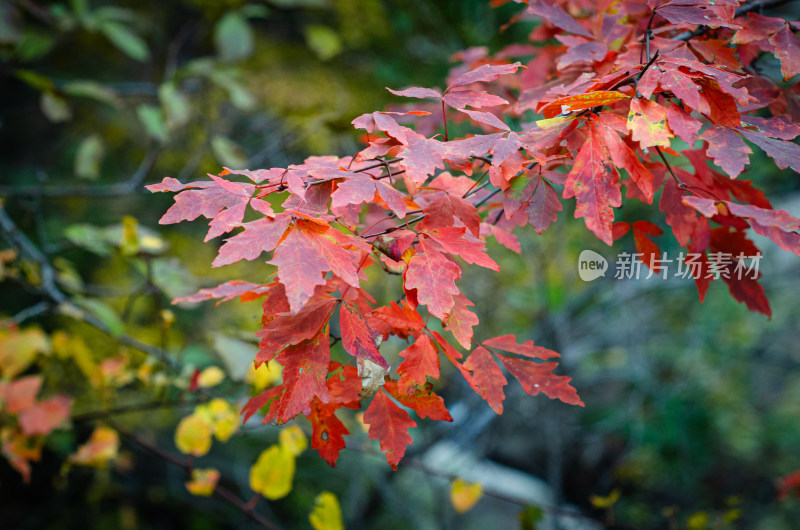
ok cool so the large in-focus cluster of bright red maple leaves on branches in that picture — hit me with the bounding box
[148,0,800,467]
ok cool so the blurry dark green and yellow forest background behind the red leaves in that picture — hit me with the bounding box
[0,0,800,529]
